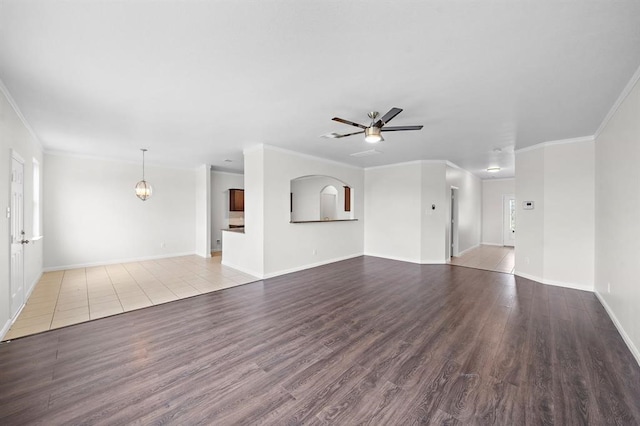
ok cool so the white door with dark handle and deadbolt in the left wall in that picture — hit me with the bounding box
[10,156,29,318]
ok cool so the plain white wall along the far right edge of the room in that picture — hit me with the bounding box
[595,73,640,363]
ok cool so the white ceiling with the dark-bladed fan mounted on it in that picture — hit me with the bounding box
[0,0,640,178]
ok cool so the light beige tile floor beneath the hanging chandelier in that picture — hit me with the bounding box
[4,256,258,340]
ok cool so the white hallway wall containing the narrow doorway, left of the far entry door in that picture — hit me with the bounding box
[445,164,482,258]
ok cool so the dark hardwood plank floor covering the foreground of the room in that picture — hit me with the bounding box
[0,257,640,425]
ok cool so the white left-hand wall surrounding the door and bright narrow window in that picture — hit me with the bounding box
[0,81,45,338]
